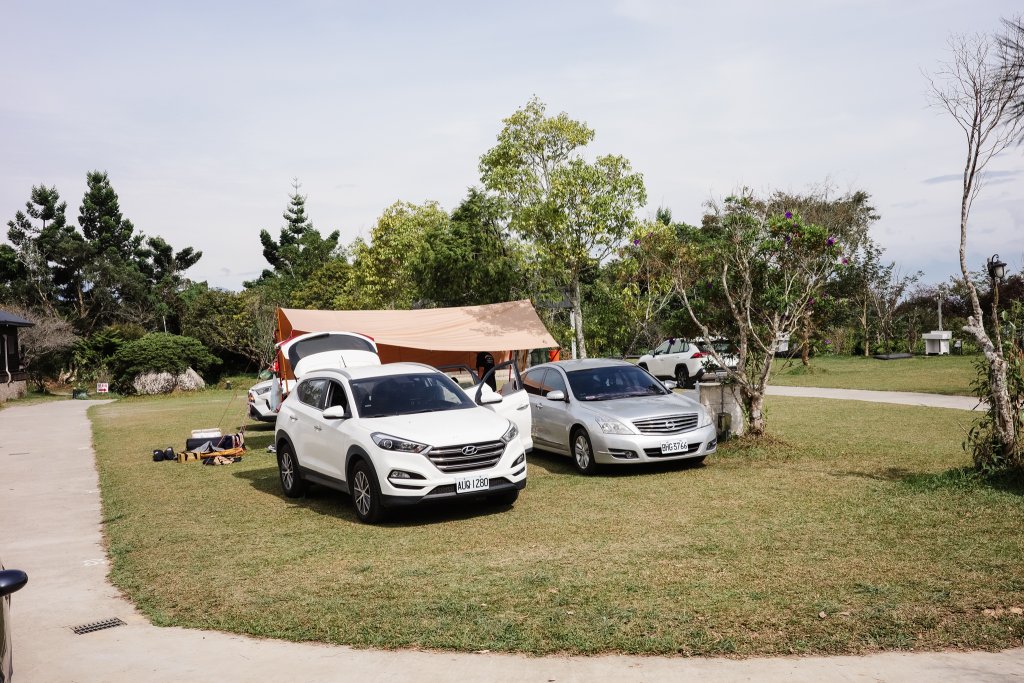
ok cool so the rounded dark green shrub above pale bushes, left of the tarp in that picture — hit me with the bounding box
[111,332,220,392]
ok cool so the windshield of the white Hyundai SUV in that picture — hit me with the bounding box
[351,373,475,418]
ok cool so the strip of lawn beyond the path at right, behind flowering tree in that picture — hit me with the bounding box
[771,355,978,396]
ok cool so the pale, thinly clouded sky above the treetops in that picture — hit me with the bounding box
[0,0,1024,290]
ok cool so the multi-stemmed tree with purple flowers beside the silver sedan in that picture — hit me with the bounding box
[664,189,842,436]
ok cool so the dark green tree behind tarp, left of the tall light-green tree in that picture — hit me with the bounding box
[410,187,525,306]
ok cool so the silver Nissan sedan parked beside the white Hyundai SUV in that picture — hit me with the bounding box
[522,358,718,474]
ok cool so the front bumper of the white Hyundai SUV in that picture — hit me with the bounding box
[374,439,526,507]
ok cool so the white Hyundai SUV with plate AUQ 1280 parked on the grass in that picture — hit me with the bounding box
[275,362,528,522]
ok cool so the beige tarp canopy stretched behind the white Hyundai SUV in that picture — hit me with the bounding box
[278,299,558,368]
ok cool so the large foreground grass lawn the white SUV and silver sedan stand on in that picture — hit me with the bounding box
[90,391,1024,655]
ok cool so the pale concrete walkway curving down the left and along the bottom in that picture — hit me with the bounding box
[0,400,1024,683]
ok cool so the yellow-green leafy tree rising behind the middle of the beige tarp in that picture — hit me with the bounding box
[345,202,449,309]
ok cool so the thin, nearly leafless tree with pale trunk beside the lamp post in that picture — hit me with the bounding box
[929,31,1024,468]
